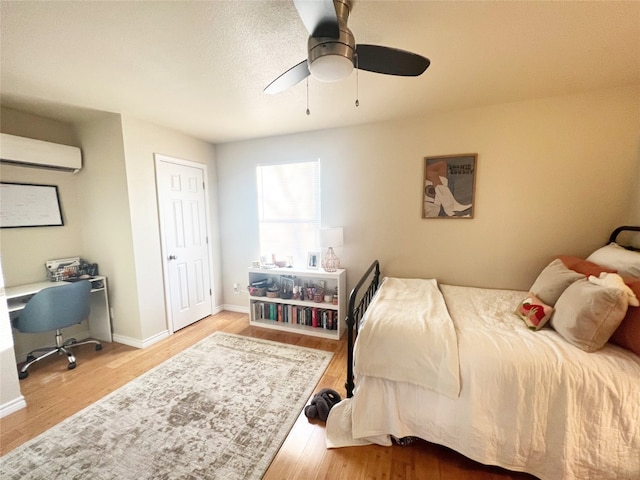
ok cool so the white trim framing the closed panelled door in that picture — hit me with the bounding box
[153,153,216,335]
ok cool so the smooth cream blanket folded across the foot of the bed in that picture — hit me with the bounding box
[354,277,460,398]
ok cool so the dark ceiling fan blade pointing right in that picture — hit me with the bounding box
[356,44,431,77]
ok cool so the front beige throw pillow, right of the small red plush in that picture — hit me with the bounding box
[551,279,627,352]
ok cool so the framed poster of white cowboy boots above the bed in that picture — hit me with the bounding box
[422,153,478,218]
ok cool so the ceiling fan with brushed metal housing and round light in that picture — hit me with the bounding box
[264,0,431,94]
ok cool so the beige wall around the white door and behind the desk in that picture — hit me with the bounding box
[0,109,222,407]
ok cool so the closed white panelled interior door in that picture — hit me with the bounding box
[156,155,212,332]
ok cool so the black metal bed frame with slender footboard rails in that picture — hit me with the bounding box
[345,225,640,398]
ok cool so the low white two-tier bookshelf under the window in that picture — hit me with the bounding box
[249,268,347,340]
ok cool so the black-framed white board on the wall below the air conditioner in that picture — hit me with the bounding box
[0,182,64,228]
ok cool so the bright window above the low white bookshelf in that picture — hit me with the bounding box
[256,160,320,266]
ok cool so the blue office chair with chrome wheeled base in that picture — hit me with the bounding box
[12,280,102,379]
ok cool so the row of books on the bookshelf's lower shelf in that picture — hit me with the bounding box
[251,302,338,330]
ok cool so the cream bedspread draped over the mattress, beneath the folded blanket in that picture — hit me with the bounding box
[327,285,640,480]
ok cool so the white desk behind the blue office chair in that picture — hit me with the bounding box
[5,275,113,342]
